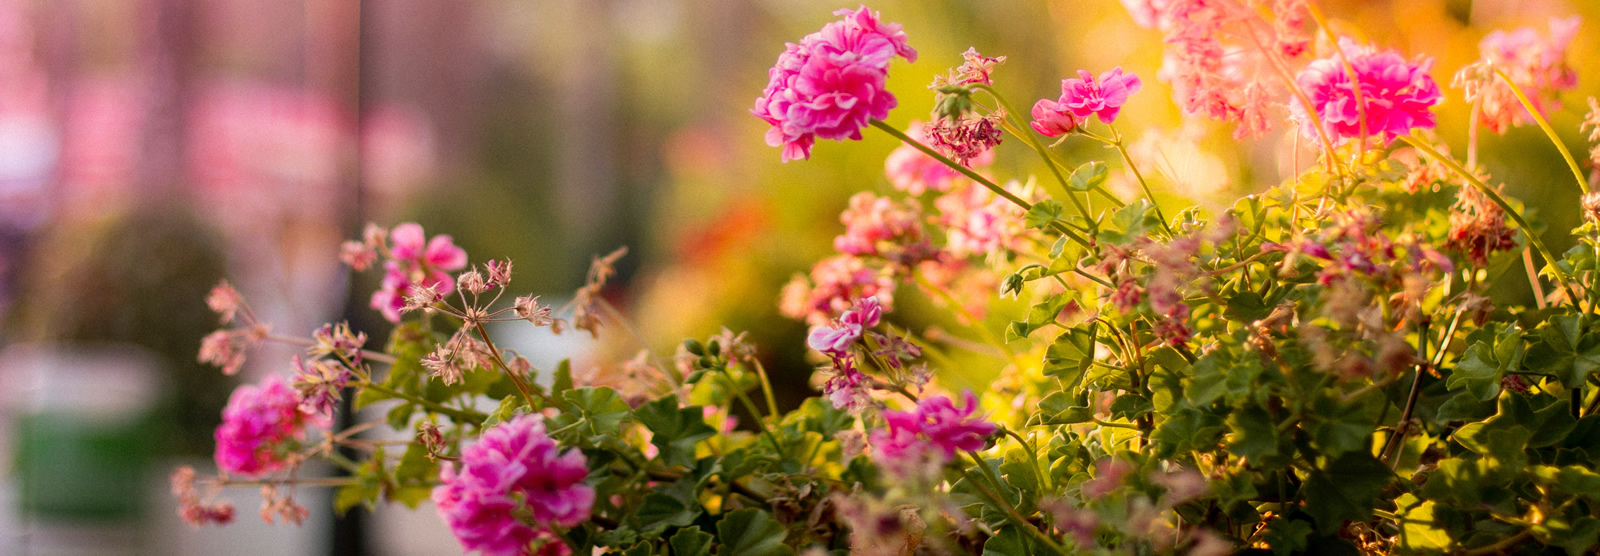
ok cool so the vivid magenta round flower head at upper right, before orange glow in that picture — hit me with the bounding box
[1290,38,1445,144]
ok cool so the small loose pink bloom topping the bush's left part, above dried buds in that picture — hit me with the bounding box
[371,222,467,323]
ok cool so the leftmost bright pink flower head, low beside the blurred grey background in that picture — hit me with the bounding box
[216,375,326,476]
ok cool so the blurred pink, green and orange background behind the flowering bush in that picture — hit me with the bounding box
[0,0,1600,554]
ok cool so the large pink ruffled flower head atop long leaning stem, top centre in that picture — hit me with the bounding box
[750,6,917,161]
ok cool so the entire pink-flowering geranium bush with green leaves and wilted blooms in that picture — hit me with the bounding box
[173,0,1600,556]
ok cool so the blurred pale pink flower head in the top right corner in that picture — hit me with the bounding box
[1458,16,1581,133]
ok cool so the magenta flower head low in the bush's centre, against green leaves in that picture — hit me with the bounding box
[870,391,997,476]
